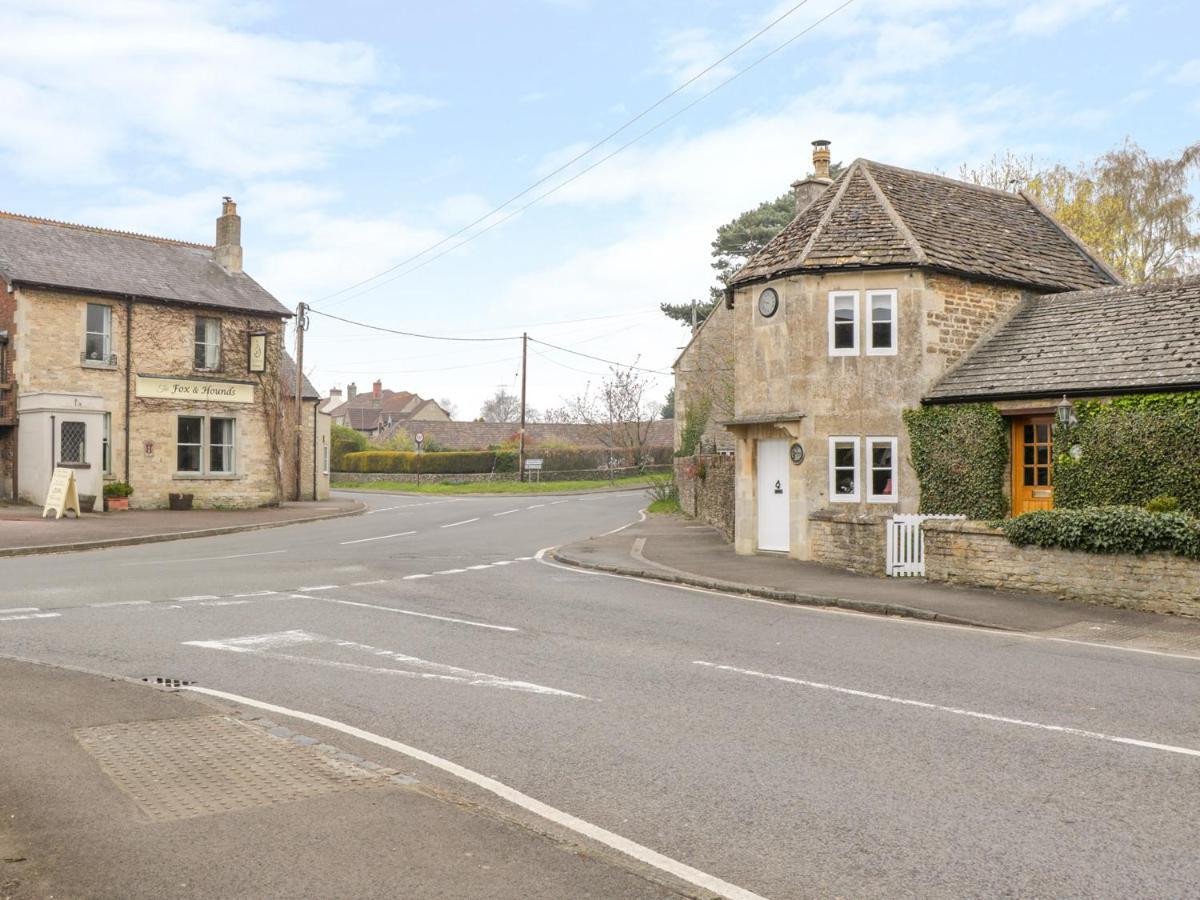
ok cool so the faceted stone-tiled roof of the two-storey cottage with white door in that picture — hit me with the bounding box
[731,160,1121,292]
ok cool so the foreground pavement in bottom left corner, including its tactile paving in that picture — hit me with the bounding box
[0,660,679,900]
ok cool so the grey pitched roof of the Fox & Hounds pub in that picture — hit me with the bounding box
[0,212,292,316]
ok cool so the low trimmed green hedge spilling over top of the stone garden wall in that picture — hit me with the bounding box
[1001,506,1200,559]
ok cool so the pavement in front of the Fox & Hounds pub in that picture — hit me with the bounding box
[0,497,366,557]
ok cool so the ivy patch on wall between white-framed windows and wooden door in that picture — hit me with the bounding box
[904,403,1008,520]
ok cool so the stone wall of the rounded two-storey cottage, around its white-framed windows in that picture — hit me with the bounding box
[724,269,1025,559]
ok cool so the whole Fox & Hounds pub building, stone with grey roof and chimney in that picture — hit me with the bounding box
[0,197,330,509]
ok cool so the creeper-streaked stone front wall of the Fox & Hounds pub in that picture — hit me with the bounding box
[16,288,284,509]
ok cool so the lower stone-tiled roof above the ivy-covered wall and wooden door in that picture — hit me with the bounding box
[926,276,1200,402]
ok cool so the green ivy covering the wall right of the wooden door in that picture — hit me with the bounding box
[1054,391,1200,516]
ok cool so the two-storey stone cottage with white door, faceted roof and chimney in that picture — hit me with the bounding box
[696,142,1121,562]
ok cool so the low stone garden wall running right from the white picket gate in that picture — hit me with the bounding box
[922,521,1200,616]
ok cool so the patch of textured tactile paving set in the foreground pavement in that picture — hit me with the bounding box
[74,715,391,822]
